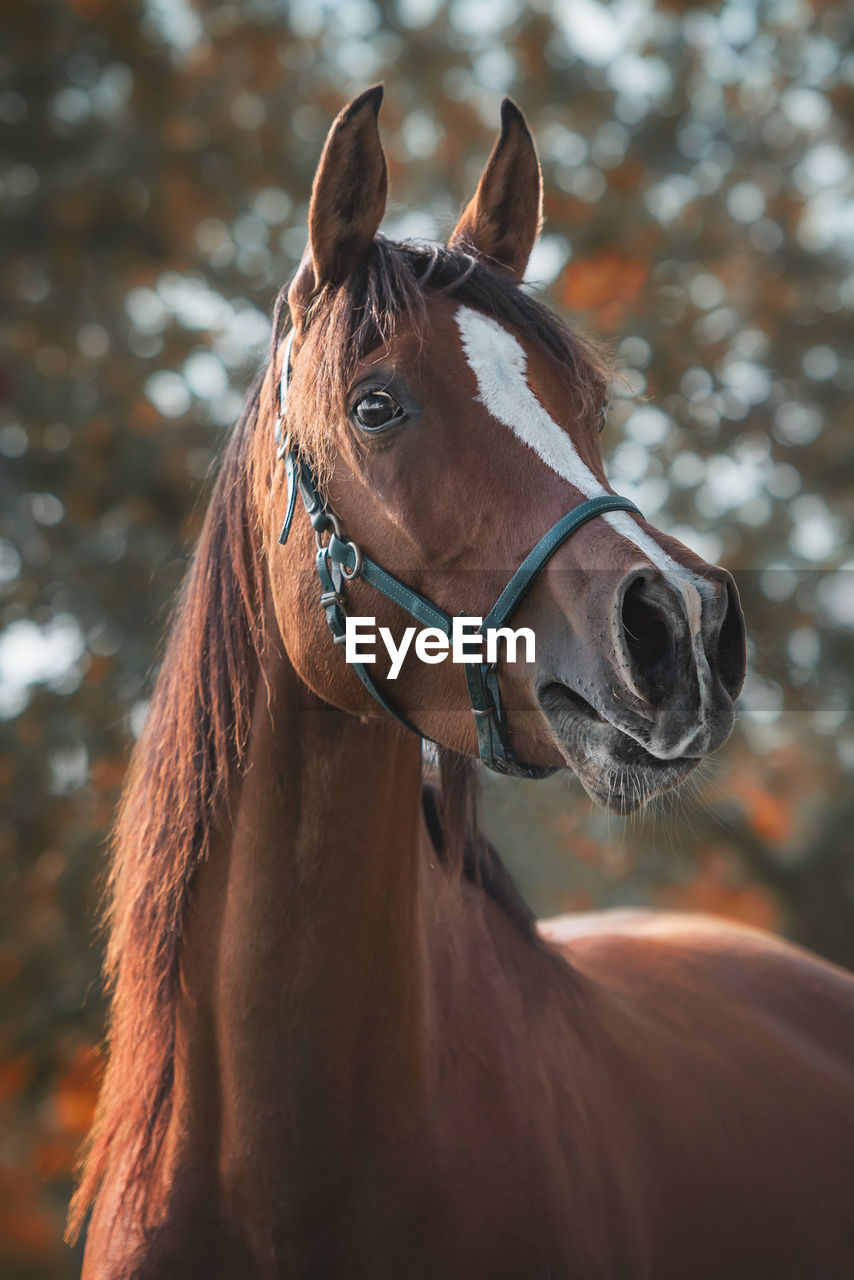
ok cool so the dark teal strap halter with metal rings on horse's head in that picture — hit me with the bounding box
[274,330,640,778]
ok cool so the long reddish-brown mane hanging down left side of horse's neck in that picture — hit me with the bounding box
[69,375,264,1239]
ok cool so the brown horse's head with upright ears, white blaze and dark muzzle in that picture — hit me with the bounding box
[255,88,745,813]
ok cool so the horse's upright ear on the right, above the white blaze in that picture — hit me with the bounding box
[448,97,543,279]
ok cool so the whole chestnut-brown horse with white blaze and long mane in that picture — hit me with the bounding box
[72,90,854,1280]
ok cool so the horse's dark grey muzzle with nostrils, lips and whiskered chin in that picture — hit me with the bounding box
[536,566,745,813]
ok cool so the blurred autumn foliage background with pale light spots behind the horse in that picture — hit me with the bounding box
[0,0,854,1277]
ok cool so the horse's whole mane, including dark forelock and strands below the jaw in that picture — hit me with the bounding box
[68,236,607,1240]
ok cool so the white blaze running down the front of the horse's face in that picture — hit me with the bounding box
[456,307,699,586]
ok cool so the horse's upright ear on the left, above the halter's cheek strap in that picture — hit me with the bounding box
[288,84,388,320]
